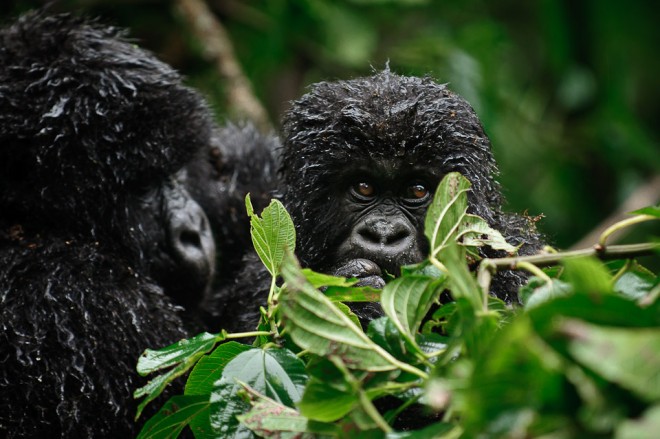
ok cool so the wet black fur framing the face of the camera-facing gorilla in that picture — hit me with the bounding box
[214,70,542,330]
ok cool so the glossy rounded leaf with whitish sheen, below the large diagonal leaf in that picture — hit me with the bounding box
[210,348,307,437]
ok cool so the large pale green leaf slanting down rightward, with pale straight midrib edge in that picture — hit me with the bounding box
[280,254,412,372]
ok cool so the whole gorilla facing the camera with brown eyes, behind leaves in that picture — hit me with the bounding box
[214,70,542,330]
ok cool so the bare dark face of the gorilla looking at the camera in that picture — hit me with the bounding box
[331,164,438,288]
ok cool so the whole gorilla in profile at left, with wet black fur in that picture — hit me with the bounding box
[0,14,215,437]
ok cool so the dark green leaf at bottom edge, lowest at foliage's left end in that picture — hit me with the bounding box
[138,395,209,439]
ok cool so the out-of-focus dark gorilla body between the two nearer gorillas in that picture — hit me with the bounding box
[185,122,280,331]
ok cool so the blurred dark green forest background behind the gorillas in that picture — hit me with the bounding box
[0,0,660,248]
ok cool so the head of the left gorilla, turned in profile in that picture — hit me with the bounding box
[0,14,215,310]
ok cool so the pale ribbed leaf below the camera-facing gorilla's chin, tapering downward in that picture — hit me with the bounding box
[381,276,446,352]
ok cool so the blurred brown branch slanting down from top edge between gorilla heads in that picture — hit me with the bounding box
[175,0,272,132]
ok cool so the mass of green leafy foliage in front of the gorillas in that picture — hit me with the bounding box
[136,174,660,439]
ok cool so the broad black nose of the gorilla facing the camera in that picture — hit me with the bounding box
[357,219,414,255]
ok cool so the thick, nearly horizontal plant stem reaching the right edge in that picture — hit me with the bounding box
[481,243,660,271]
